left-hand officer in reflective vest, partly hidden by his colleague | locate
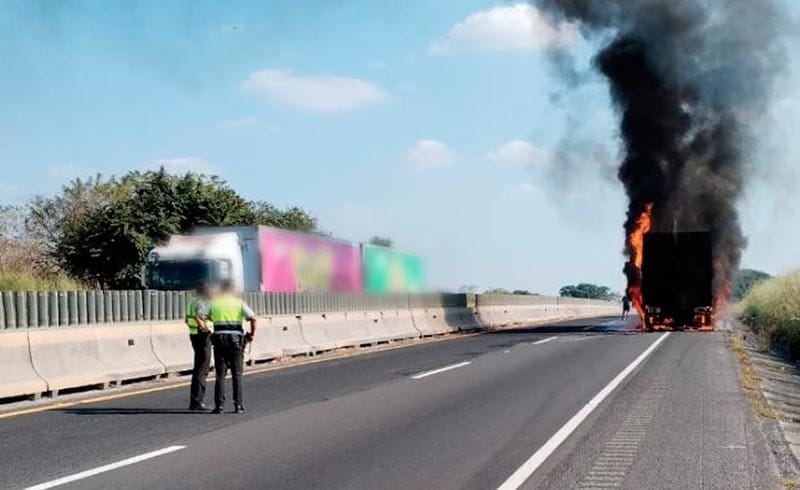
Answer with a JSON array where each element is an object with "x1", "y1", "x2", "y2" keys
[{"x1": 186, "y1": 282, "x2": 214, "y2": 411}]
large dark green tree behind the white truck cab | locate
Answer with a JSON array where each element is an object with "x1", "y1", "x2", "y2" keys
[{"x1": 30, "y1": 169, "x2": 317, "y2": 288}]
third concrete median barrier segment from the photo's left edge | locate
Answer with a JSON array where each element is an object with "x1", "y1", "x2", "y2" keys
[{"x1": 95, "y1": 323, "x2": 165, "y2": 383}]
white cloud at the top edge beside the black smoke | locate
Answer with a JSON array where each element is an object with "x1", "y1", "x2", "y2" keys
[{"x1": 431, "y1": 3, "x2": 580, "y2": 54}]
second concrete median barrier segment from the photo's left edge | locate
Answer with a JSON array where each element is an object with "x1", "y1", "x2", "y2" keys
[{"x1": 28, "y1": 327, "x2": 114, "y2": 395}]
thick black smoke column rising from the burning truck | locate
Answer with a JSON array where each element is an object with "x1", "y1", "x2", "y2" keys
[{"x1": 536, "y1": 0, "x2": 786, "y2": 297}]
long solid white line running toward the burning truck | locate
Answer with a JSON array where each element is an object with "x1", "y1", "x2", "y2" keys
[{"x1": 497, "y1": 332, "x2": 669, "y2": 490}]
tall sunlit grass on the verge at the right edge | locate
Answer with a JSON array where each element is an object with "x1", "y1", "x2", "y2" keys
[{"x1": 739, "y1": 270, "x2": 800, "y2": 359}]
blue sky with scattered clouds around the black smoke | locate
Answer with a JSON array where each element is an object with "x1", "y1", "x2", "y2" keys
[{"x1": 0, "y1": 0, "x2": 800, "y2": 293}]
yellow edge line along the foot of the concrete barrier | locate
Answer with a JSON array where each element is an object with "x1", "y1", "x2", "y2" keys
[{"x1": 0, "y1": 332, "x2": 481, "y2": 420}]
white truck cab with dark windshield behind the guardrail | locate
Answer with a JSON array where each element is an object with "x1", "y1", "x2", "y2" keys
[{"x1": 142, "y1": 232, "x2": 244, "y2": 291}]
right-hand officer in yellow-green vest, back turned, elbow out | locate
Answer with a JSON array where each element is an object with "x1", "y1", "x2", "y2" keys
[{"x1": 211, "y1": 280, "x2": 256, "y2": 413}]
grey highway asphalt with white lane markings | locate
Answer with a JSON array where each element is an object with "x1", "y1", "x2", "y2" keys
[{"x1": 0, "y1": 319, "x2": 780, "y2": 489}]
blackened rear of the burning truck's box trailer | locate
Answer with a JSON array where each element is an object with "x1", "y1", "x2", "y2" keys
[{"x1": 642, "y1": 231, "x2": 714, "y2": 330}]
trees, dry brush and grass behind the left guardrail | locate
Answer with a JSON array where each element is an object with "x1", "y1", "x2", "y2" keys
[{"x1": 0, "y1": 169, "x2": 319, "y2": 290}]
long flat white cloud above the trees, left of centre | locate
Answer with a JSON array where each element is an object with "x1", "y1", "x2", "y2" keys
[{"x1": 243, "y1": 69, "x2": 386, "y2": 113}]
